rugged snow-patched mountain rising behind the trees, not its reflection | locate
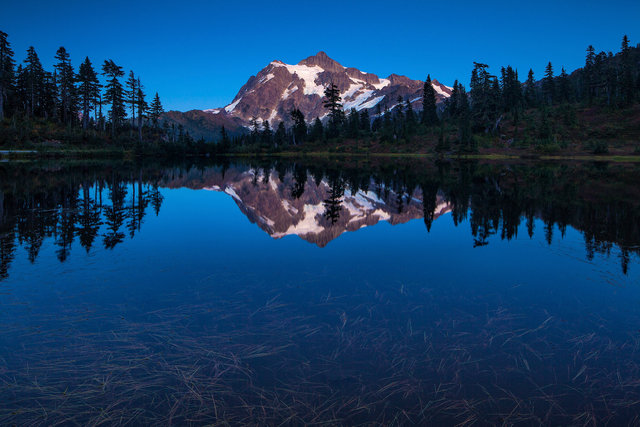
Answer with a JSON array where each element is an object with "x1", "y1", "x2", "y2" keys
[{"x1": 164, "y1": 52, "x2": 451, "y2": 139}]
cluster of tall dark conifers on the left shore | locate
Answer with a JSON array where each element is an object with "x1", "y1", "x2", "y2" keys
[{"x1": 0, "y1": 31, "x2": 171, "y2": 147}]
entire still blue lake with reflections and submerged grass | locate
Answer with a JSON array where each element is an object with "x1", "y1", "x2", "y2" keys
[{"x1": 0, "y1": 160, "x2": 640, "y2": 425}]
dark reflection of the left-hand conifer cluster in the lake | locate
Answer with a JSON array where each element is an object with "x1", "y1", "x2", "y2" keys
[{"x1": 0, "y1": 166, "x2": 163, "y2": 279}]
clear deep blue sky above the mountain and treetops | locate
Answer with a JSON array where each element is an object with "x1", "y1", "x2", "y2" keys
[{"x1": 0, "y1": 0, "x2": 640, "y2": 110}]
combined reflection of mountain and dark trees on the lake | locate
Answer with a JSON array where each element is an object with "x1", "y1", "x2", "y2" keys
[{"x1": 0, "y1": 159, "x2": 640, "y2": 279}]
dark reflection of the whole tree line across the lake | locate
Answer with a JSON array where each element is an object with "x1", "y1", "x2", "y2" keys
[{"x1": 0, "y1": 158, "x2": 640, "y2": 277}]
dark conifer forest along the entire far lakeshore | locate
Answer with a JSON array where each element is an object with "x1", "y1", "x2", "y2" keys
[{"x1": 0, "y1": 31, "x2": 640, "y2": 155}]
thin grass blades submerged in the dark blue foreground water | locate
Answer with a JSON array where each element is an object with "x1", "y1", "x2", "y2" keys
[{"x1": 0, "y1": 275, "x2": 640, "y2": 425}]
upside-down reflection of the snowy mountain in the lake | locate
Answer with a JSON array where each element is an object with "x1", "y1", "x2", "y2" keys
[{"x1": 163, "y1": 168, "x2": 451, "y2": 247}]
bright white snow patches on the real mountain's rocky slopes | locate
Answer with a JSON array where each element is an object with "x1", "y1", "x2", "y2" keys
[{"x1": 203, "y1": 53, "x2": 452, "y2": 121}]
